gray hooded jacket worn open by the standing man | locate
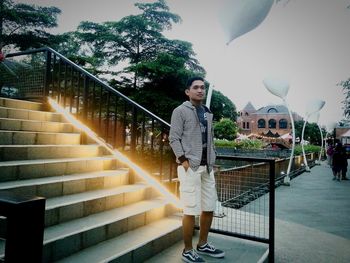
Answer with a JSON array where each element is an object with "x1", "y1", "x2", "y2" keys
[{"x1": 169, "y1": 101, "x2": 216, "y2": 171}]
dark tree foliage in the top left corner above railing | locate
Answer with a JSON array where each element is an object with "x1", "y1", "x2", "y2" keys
[{"x1": 0, "y1": 0, "x2": 61, "y2": 51}]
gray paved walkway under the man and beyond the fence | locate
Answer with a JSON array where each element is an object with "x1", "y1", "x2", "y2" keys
[{"x1": 147, "y1": 163, "x2": 350, "y2": 263}]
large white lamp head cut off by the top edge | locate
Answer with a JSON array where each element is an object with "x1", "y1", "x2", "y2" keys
[{"x1": 219, "y1": 0, "x2": 274, "y2": 44}]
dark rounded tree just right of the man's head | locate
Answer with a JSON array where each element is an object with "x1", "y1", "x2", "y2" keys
[{"x1": 210, "y1": 90, "x2": 237, "y2": 121}]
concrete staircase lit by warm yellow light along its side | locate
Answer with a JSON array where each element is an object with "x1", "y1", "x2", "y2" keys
[{"x1": 0, "y1": 98, "x2": 182, "y2": 263}]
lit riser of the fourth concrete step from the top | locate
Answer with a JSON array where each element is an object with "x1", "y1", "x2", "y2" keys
[{"x1": 0, "y1": 130, "x2": 80, "y2": 145}]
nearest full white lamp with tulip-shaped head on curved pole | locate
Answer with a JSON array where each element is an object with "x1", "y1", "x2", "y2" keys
[{"x1": 263, "y1": 78, "x2": 295, "y2": 185}]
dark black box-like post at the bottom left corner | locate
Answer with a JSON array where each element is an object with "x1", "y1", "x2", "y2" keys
[{"x1": 0, "y1": 191, "x2": 45, "y2": 263}]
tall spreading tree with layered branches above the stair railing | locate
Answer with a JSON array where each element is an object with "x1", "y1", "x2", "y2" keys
[{"x1": 78, "y1": 0, "x2": 181, "y2": 89}]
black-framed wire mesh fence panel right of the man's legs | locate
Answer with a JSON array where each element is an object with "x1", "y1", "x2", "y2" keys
[{"x1": 206, "y1": 157, "x2": 275, "y2": 246}]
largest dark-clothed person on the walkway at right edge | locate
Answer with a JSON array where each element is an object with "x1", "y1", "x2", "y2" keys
[{"x1": 332, "y1": 142, "x2": 348, "y2": 181}]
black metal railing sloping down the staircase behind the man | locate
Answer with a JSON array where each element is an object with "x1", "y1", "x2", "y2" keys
[{"x1": 0, "y1": 48, "x2": 176, "y2": 191}]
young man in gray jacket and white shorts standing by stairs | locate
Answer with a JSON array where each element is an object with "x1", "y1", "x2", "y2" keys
[{"x1": 169, "y1": 77, "x2": 225, "y2": 262}]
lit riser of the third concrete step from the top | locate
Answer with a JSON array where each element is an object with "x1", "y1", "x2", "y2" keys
[{"x1": 0, "y1": 118, "x2": 79, "y2": 132}]
